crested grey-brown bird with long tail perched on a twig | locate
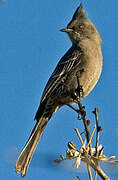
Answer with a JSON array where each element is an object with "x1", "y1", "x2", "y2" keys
[{"x1": 16, "y1": 4, "x2": 102, "y2": 176}]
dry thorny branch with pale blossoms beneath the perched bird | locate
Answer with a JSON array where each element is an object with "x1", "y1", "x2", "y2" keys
[{"x1": 55, "y1": 99, "x2": 118, "y2": 180}]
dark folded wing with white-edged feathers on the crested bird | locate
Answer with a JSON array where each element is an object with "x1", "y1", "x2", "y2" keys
[{"x1": 41, "y1": 45, "x2": 82, "y2": 103}]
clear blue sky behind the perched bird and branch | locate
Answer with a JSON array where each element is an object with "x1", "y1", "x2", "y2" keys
[{"x1": 0, "y1": 0, "x2": 118, "y2": 180}]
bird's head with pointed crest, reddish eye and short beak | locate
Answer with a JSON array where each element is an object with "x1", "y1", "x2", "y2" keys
[{"x1": 61, "y1": 4, "x2": 102, "y2": 44}]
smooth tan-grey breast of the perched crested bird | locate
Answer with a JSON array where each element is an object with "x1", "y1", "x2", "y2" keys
[{"x1": 80, "y1": 41, "x2": 103, "y2": 97}]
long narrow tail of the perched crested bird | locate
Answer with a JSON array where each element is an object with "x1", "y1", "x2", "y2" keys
[{"x1": 15, "y1": 108, "x2": 56, "y2": 177}]
